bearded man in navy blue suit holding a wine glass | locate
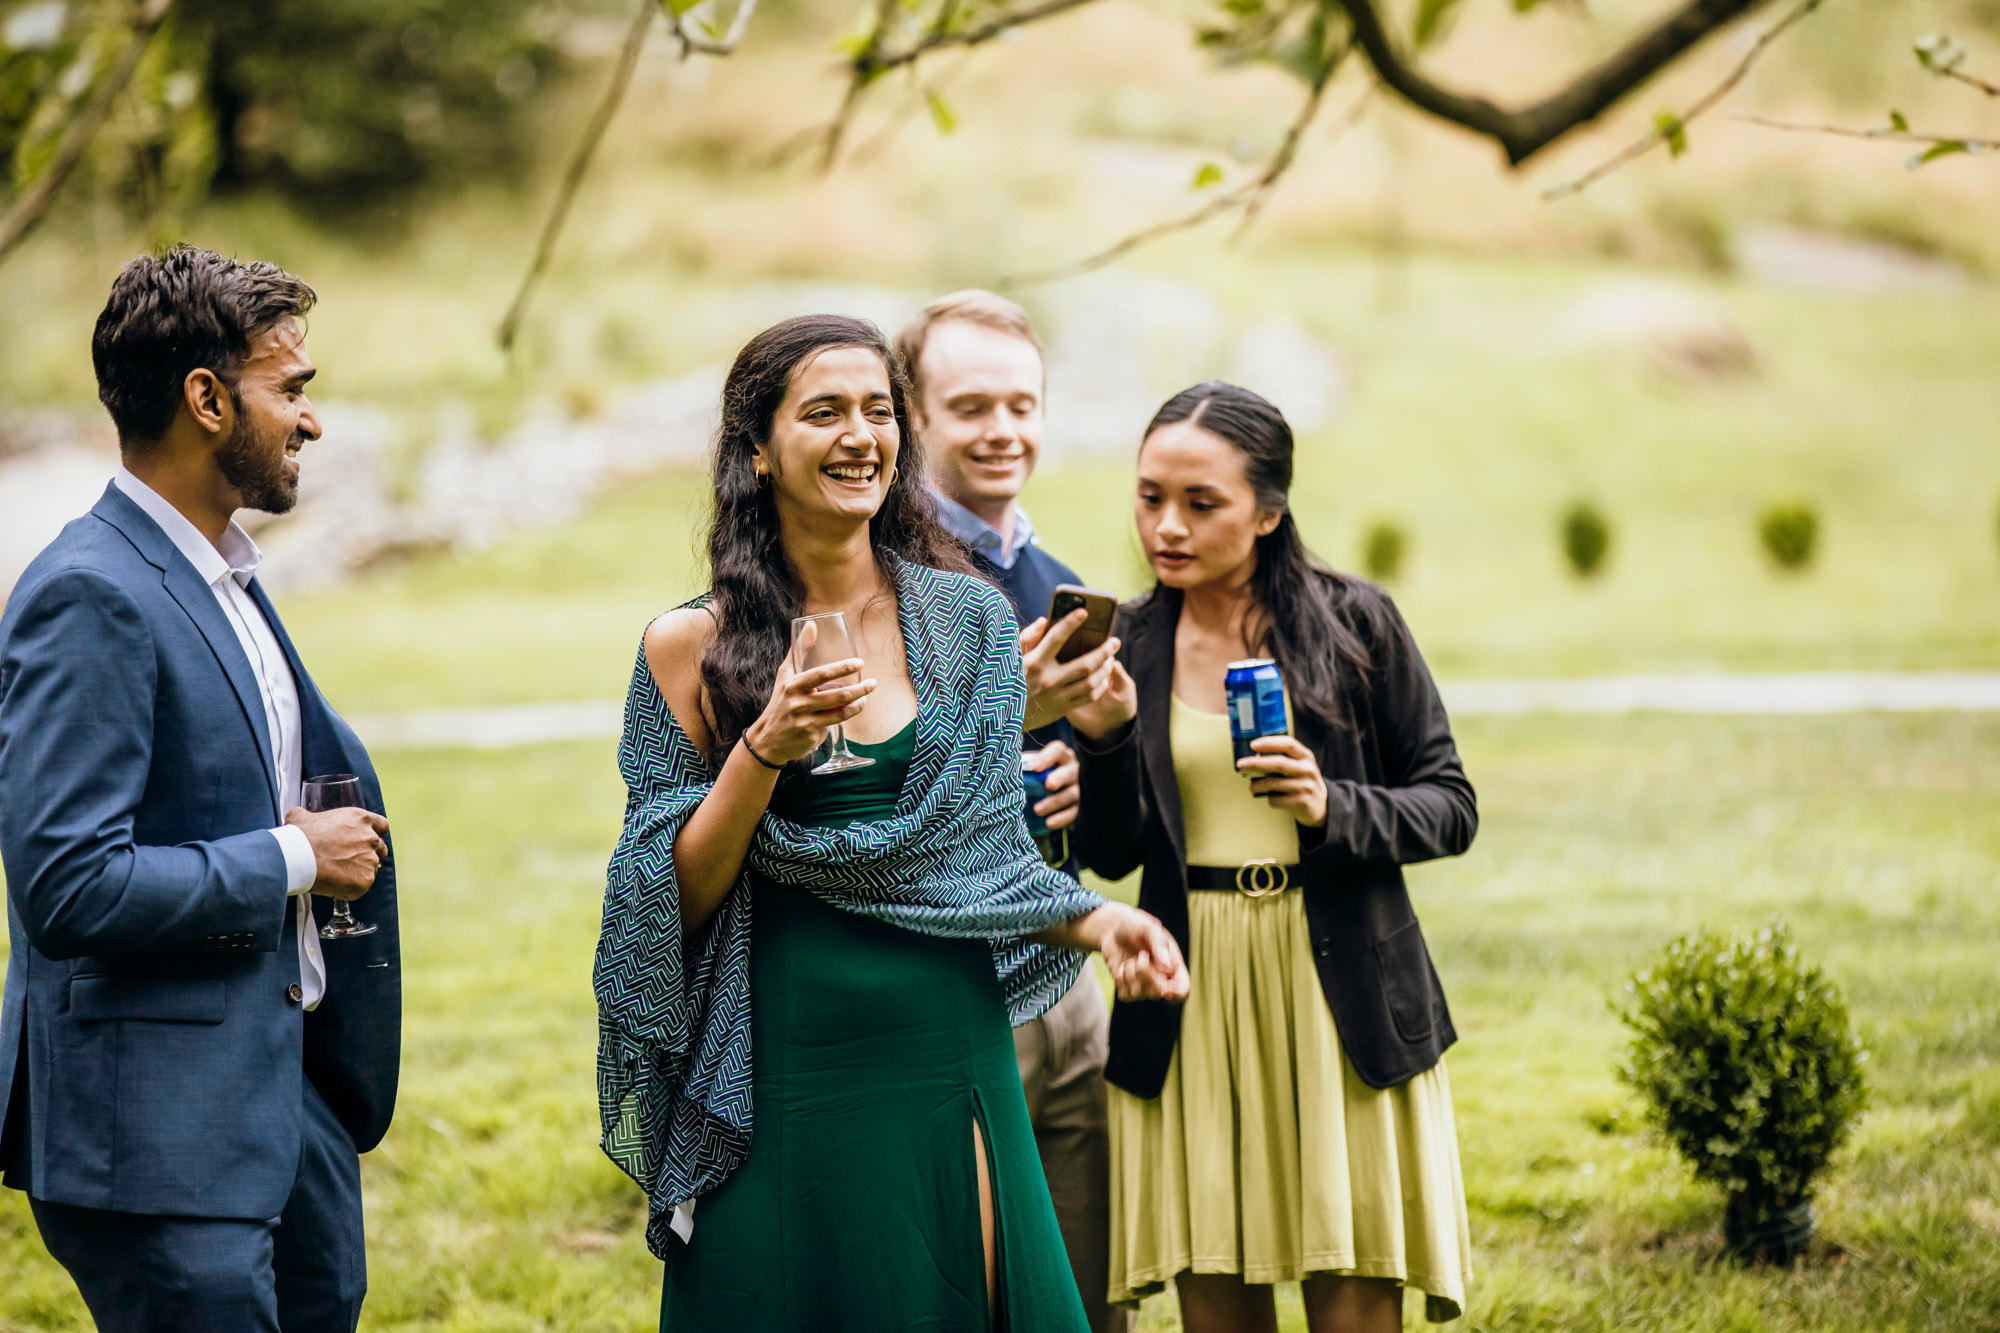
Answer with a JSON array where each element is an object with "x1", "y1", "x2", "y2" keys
[{"x1": 0, "y1": 246, "x2": 402, "y2": 1333}]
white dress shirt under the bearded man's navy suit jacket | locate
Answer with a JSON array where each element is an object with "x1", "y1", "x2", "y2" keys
[{"x1": 116, "y1": 468, "x2": 326, "y2": 1009}]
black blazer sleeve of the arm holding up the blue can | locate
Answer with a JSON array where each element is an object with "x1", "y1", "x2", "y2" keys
[{"x1": 1312, "y1": 594, "x2": 1480, "y2": 865}]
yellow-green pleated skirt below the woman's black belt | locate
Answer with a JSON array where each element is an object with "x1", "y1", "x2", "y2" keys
[{"x1": 1110, "y1": 893, "x2": 1472, "y2": 1321}]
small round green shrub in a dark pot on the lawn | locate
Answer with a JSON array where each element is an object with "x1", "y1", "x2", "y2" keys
[{"x1": 1618, "y1": 923, "x2": 1868, "y2": 1259}]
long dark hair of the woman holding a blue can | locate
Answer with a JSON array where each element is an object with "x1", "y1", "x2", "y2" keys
[{"x1": 1142, "y1": 380, "x2": 1370, "y2": 729}]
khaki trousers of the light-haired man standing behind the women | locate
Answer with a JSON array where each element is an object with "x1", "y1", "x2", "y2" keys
[{"x1": 1014, "y1": 967, "x2": 1132, "y2": 1333}]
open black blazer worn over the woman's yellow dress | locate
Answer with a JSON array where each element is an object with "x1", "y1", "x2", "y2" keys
[{"x1": 1082, "y1": 576, "x2": 1478, "y2": 1097}]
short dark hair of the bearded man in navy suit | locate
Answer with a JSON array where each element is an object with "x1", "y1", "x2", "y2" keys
[{"x1": 90, "y1": 244, "x2": 318, "y2": 452}]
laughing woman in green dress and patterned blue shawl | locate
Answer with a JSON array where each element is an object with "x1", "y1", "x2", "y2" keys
[{"x1": 596, "y1": 316, "x2": 1186, "y2": 1333}]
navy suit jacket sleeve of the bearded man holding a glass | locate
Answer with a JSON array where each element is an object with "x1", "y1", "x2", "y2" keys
[{"x1": 0, "y1": 568, "x2": 286, "y2": 959}]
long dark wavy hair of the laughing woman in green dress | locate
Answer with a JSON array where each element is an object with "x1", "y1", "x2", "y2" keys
[{"x1": 702, "y1": 314, "x2": 970, "y2": 761}]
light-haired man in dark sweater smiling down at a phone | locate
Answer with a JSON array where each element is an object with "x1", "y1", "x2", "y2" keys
[{"x1": 896, "y1": 290, "x2": 1132, "y2": 1333}]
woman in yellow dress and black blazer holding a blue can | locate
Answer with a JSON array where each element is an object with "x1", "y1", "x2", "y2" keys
[{"x1": 1070, "y1": 382, "x2": 1478, "y2": 1333}]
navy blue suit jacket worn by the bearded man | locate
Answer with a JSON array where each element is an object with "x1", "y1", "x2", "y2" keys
[{"x1": 0, "y1": 486, "x2": 402, "y2": 1219}]
